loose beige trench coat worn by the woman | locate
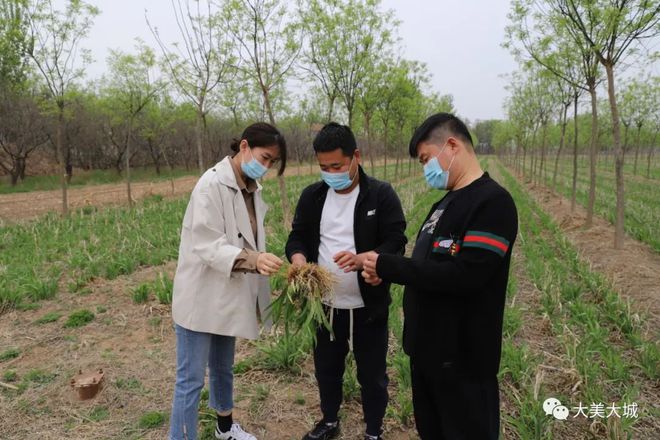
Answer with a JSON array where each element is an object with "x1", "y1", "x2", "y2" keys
[{"x1": 172, "y1": 157, "x2": 270, "y2": 339}]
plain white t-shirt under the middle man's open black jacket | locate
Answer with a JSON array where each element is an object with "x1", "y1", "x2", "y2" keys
[{"x1": 319, "y1": 185, "x2": 364, "y2": 309}]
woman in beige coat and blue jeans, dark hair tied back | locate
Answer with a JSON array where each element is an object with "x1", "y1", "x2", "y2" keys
[{"x1": 169, "y1": 123, "x2": 286, "y2": 440}]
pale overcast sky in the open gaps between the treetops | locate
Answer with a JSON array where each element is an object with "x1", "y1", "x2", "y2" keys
[{"x1": 73, "y1": 0, "x2": 516, "y2": 120}]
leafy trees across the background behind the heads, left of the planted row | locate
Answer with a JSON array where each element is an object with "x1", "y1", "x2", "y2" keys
[{"x1": 0, "y1": 0, "x2": 453, "y2": 217}]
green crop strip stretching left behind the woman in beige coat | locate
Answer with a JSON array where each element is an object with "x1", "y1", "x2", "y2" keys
[{"x1": 0, "y1": 164, "x2": 412, "y2": 314}]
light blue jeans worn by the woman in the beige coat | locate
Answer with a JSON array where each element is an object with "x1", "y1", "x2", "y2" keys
[{"x1": 170, "y1": 325, "x2": 236, "y2": 440}]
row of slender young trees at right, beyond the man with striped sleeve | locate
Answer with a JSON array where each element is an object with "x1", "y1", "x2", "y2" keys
[{"x1": 496, "y1": 0, "x2": 660, "y2": 249}]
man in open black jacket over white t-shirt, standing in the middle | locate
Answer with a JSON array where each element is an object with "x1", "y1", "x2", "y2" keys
[{"x1": 286, "y1": 123, "x2": 406, "y2": 440}]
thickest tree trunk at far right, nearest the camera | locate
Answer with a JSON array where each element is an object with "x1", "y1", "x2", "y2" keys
[{"x1": 605, "y1": 65, "x2": 626, "y2": 249}]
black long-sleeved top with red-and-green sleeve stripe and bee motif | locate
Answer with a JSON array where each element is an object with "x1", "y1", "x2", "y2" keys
[{"x1": 376, "y1": 173, "x2": 518, "y2": 377}]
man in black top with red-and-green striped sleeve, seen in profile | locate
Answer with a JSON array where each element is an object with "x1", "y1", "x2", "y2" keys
[{"x1": 363, "y1": 113, "x2": 518, "y2": 440}]
